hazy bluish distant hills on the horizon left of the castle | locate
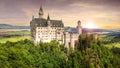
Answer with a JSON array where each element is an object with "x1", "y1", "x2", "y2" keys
[{"x1": 0, "y1": 24, "x2": 30, "y2": 29}]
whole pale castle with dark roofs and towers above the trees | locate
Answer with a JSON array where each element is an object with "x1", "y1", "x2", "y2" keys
[{"x1": 30, "y1": 7, "x2": 82, "y2": 49}]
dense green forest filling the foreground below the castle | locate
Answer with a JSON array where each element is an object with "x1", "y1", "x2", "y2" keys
[{"x1": 0, "y1": 36, "x2": 120, "y2": 68}]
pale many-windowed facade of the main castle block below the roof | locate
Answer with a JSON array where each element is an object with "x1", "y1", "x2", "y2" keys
[{"x1": 36, "y1": 27, "x2": 63, "y2": 43}]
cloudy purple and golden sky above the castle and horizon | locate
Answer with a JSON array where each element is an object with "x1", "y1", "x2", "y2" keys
[{"x1": 0, "y1": 0, "x2": 120, "y2": 29}]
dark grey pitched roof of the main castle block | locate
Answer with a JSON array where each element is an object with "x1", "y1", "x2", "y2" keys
[{"x1": 31, "y1": 18, "x2": 64, "y2": 27}]
